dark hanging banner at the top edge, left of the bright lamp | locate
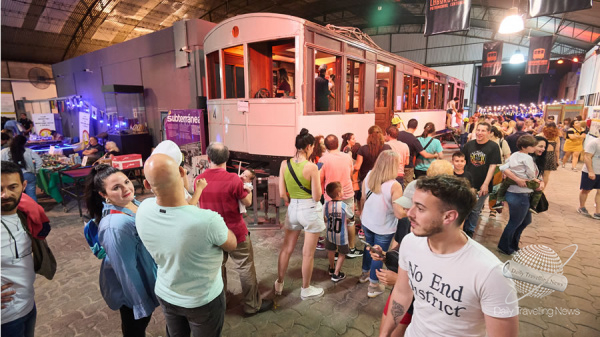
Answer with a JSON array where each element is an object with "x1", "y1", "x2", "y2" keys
[{"x1": 425, "y1": 0, "x2": 471, "y2": 36}]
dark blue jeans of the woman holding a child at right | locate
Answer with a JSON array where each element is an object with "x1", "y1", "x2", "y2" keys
[{"x1": 498, "y1": 192, "x2": 531, "y2": 254}]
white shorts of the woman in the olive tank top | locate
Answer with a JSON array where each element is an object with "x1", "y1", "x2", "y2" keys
[{"x1": 285, "y1": 199, "x2": 325, "y2": 233}]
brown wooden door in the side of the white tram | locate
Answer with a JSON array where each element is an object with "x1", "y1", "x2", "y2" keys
[{"x1": 375, "y1": 63, "x2": 395, "y2": 130}]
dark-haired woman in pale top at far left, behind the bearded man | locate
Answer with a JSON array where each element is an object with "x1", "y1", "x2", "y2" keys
[{"x1": 0, "y1": 135, "x2": 42, "y2": 202}]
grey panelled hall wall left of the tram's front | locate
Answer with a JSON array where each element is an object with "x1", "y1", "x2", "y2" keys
[{"x1": 53, "y1": 20, "x2": 216, "y2": 144}]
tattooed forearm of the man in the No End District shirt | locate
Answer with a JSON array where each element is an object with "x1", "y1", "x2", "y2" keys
[{"x1": 379, "y1": 268, "x2": 413, "y2": 337}]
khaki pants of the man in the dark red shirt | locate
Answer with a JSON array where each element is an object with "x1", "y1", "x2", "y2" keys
[{"x1": 221, "y1": 235, "x2": 262, "y2": 313}]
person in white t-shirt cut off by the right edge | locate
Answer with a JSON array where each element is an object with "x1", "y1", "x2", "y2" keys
[{"x1": 577, "y1": 137, "x2": 600, "y2": 220}]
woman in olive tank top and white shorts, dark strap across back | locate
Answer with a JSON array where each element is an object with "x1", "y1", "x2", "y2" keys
[{"x1": 275, "y1": 129, "x2": 325, "y2": 300}]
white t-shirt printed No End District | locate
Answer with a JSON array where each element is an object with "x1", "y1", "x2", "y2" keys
[{"x1": 398, "y1": 233, "x2": 519, "y2": 337}]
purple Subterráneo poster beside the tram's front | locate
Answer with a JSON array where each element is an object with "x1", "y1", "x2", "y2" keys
[{"x1": 165, "y1": 109, "x2": 208, "y2": 186}]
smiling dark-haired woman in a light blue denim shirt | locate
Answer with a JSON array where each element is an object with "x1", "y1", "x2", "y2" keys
[{"x1": 85, "y1": 164, "x2": 159, "y2": 337}]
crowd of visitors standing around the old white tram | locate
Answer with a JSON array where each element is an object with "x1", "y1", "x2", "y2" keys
[{"x1": 2, "y1": 107, "x2": 600, "y2": 336}]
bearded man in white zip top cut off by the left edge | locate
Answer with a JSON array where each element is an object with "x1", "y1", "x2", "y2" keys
[{"x1": 1, "y1": 161, "x2": 37, "y2": 337}]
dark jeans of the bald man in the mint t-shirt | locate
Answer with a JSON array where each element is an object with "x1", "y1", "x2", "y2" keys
[{"x1": 157, "y1": 291, "x2": 225, "y2": 337}]
